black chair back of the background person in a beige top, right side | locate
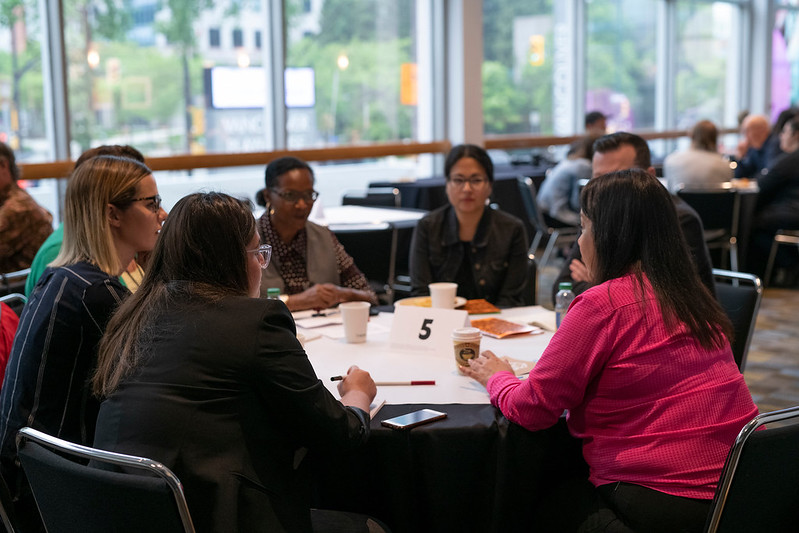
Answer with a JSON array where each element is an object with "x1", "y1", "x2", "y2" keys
[{"x1": 677, "y1": 183, "x2": 741, "y2": 272}]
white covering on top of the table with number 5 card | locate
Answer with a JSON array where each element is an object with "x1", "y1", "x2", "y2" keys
[{"x1": 295, "y1": 306, "x2": 555, "y2": 404}]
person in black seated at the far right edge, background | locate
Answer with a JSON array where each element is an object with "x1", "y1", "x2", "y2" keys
[{"x1": 746, "y1": 117, "x2": 799, "y2": 276}]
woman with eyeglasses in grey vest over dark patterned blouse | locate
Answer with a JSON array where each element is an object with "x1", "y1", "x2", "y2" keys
[{"x1": 258, "y1": 157, "x2": 377, "y2": 311}]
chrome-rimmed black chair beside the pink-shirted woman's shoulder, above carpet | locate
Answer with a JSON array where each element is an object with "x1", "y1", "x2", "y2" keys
[{"x1": 713, "y1": 268, "x2": 763, "y2": 372}]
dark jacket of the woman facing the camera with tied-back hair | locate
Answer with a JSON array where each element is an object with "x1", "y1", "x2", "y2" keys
[{"x1": 410, "y1": 204, "x2": 530, "y2": 307}]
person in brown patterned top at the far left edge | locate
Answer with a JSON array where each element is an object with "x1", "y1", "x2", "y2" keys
[{"x1": 0, "y1": 142, "x2": 53, "y2": 273}]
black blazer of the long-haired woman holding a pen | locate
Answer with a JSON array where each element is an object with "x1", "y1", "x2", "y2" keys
[{"x1": 94, "y1": 296, "x2": 369, "y2": 532}]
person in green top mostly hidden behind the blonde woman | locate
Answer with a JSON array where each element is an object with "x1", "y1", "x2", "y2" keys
[{"x1": 25, "y1": 144, "x2": 144, "y2": 296}]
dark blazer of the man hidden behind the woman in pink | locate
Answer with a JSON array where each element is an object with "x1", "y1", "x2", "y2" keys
[{"x1": 552, "y1": 196, "x2": 716, "y2": 304}]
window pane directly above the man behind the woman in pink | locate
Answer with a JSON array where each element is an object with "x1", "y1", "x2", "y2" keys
[{"x1": 585, "y1": 0, "x2": 658, "y2": 131}]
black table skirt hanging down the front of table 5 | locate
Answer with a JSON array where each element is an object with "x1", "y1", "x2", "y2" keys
[{"x1": 314, "y1": 404, "x2": 588, "y2": 533}]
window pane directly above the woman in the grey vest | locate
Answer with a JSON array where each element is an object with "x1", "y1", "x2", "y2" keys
[{"x1": 286, "y1": 0, "x2": 418, "y2": 148}]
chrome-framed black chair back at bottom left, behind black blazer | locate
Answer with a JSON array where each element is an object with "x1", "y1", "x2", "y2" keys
[{"x1": 17, "y1": 427, "x2": 194, "y2": 533}]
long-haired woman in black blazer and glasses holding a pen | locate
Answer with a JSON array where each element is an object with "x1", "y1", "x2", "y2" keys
[{"x1": 93, "y1": 193, "x2": 376, "y2": 531}]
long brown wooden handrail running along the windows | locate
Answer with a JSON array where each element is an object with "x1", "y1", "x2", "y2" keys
[{"x1": 19, "y1": 128, "x2": 738, "y2": 180}]
